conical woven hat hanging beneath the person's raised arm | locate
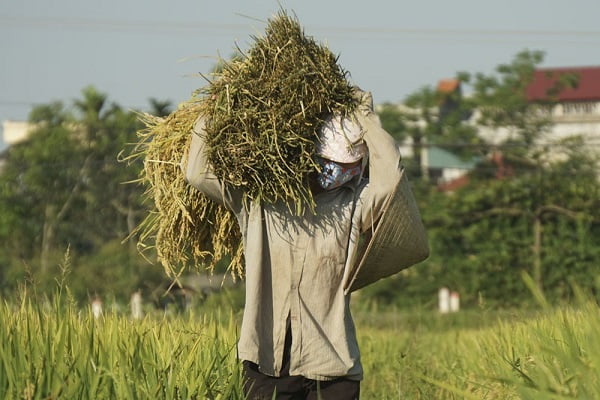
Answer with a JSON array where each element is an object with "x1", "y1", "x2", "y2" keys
[{"x1": 346, "y1": 170, "x2": 429, "y2": 292}]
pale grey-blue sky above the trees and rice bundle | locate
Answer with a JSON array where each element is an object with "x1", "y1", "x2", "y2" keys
[{"x1": 0, "y1": 0, "x2": 600, "y2": 147}]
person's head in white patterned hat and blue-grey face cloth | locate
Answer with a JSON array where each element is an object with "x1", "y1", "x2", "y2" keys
[{"x1": 317, "y1": 116, "x2": 368, "y2": 189}]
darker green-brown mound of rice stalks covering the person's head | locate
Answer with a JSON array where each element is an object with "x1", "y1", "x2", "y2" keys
[{"x1": 200, "y1": 11, "x2": 356, "y2": 214}]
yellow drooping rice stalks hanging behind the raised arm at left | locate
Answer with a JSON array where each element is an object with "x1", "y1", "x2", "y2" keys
[{"x1": 132, "y1": 100, "x2": 242, "y2": 276}]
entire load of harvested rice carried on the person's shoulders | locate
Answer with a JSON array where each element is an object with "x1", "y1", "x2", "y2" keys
[{"x1": 133, "y1": 10, "x2": 357, "y2": 274}]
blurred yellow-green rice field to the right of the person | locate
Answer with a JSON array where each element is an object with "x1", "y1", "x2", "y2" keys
[{"x1": 358, "y1": 301, "x2": 600, "y2": 400}]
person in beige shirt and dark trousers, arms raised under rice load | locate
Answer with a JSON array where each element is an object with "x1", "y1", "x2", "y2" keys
[{"x1": 186, "y1": 90, "x2": 401, "y2": 400}]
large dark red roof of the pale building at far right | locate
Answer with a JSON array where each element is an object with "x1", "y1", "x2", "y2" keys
[{"x1": 526, "y1": 67, "x2": 600, "y2": 102}]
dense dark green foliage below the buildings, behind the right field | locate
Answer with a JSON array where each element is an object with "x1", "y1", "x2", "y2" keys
[{"x1": 396, "y1": 162, "x2": 600, "y2": 305}]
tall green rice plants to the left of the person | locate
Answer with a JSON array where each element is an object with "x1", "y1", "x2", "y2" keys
[{"x1": 0, "y1": 290, "x2": 243, "y2": 399}]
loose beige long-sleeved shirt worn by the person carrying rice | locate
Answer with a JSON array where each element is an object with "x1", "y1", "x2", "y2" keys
[{"x1": 186, "y1": 97, "x2": 400, "y2": 380}]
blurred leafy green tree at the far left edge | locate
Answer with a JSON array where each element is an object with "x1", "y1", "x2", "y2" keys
[{"x1": 3, "y1": 103, "x2": 85, "y2": 271}]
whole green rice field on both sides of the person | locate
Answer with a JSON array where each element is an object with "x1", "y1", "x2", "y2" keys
[{"x1": 0, "y1": 284, "x2": 600, "y2": 400}]
